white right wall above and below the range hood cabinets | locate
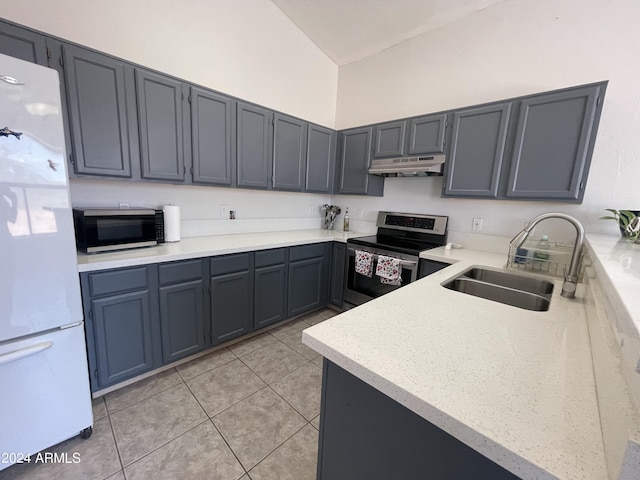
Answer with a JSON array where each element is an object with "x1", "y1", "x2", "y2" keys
[{"x1": 333, "y1": 0, "x2": 640, "y2": 246}]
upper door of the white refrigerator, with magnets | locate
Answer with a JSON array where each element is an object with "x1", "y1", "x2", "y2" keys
[{"x1": 0, "y1": 55, "x2": 83, "y2": 343}]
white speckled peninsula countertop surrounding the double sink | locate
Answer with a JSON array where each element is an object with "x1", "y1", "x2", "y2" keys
[{"x1": 303, "y1": 244, "x2": 607, "y2": 480}]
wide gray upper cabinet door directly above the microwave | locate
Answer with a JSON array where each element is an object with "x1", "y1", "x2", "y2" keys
[{"x1": 62, "y1": 45, "x2": 135, "y2": 178}]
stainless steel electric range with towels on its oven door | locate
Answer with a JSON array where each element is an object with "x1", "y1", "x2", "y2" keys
[{"x1": 343, "y1": 212, "x2": 449, "y2": 305}]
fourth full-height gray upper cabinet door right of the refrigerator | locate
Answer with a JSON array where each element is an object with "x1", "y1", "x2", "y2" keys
[{"x1": 236, "y1": 102, "x2": 272, "y2": 188}]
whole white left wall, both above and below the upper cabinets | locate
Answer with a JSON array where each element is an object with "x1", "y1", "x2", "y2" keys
[{"x1": 0, "y1": 0, "x2": 338, "y2": 232}]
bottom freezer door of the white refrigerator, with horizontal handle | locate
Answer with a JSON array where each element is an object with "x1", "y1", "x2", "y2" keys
[{"x1": 0, "y1": 323, "x2": 93, "y2": 470}]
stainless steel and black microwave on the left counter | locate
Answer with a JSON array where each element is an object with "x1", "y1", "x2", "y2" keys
[{"x1": 73, "y1": 208, "x2": 164, "y2": 253}]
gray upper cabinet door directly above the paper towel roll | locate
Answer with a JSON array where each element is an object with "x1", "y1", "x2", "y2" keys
[{"x1": 136, "y1": 69, "x2": 185, "y2": 182}]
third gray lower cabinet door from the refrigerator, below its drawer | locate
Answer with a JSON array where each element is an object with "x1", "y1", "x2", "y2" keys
[{"x1": 211, "y1": 271, "x2": 253, "y2": 345}]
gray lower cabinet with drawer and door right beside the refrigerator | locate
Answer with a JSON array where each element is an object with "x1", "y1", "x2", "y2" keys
[{"x1": 80, "y1": 266, "x2": 162, "y2": 391}]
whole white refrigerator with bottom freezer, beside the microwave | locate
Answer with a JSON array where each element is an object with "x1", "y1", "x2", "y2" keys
[{"x1": 0, "y1": 54, "x2": 93, "y2": 470}]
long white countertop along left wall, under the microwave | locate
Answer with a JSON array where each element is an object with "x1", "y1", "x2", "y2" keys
[{"x1": 78, "y1": 229, "x2": 365, "y2": 272}]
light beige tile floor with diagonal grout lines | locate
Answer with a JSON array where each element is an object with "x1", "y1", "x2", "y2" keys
[{"x1": 0, "y1": 309, "x2": 335, "y2": 480}]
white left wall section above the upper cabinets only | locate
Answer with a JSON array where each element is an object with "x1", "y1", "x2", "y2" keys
[{"x1": 0, "y1": 0, "x2": 338, "y2": 127}]
